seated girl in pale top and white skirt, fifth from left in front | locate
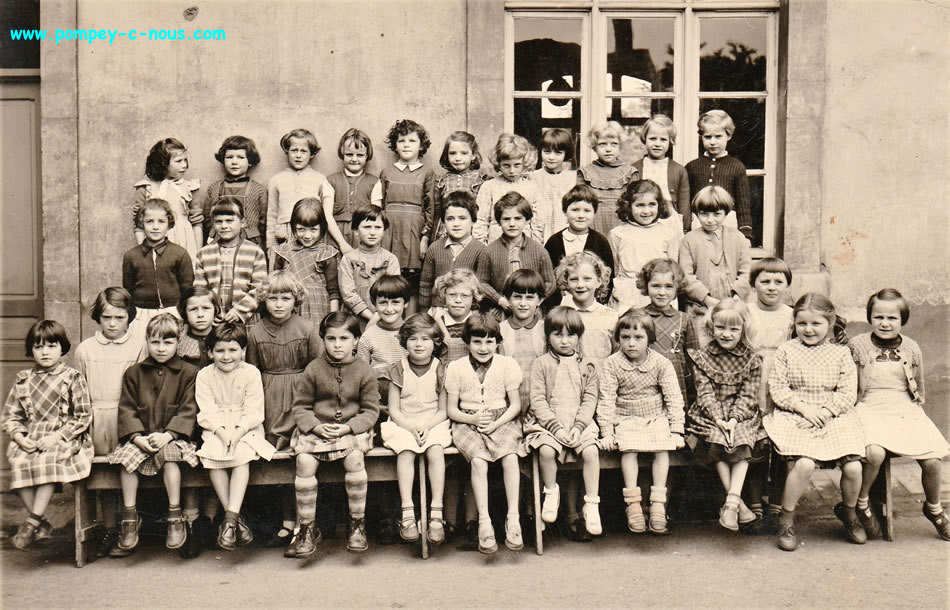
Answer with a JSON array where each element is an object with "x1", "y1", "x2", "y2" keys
[{"x1": 381, "y1": 313, "x2": 452, "y2": 544}]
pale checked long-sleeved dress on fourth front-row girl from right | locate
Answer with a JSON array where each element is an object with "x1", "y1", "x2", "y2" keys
[{"x1": 597, "y1": 349, "x2": 686, "y2": 452}]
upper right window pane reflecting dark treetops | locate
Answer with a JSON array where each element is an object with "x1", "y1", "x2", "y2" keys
[{"x1": 699, "y1": 17, "x2": 768, "y2": 91}]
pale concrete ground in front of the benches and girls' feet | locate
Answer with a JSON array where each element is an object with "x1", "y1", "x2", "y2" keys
[{"x1": 0, "y1": 462, "x2": 950, "y2": 608}]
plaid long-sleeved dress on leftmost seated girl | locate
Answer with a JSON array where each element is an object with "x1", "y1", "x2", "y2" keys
[{"x1": 3, "y1": 363, "x2": 93, "y2": 489}]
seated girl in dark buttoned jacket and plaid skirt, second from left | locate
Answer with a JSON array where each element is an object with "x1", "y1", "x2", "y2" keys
[{"x1": 109, "y1": 313, "x2": 198, "y2": 551}]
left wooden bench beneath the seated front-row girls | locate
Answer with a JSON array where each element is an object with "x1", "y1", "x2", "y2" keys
[{"x1": 73, "y1": 447, "x2": 458, "y2": 568}]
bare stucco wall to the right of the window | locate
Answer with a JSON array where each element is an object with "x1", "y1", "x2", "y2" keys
[{"x1": 820, "y1": 0, "x2": 950, "y2": 304}]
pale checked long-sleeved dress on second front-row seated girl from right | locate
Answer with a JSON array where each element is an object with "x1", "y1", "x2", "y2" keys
[{"x1": 762, "y1": 339, "x2": 865, "y2": 461}]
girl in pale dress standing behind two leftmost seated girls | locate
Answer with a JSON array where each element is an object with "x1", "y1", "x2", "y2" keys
[{"x1": 76, "y1": 286, "x2": 146, "y2": 557}]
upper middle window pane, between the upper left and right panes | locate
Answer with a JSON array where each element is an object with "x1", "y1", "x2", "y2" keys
[{"x1": 607, "y1": 17, "x2": 674, "y2": 93}]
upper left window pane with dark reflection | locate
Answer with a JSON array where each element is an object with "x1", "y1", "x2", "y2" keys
[{"x1": 515, "y1": 17, "x2": 582, "y2": 91}]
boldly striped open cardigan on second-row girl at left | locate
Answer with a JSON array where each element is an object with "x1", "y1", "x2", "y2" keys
[{"x1": 194, "y1": 239, "x2": 267, "y2": 322}]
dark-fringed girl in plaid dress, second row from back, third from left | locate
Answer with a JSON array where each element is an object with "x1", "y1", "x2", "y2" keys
[{"x1": 273, "y1": 197, "x2": 340, "y2": 324}]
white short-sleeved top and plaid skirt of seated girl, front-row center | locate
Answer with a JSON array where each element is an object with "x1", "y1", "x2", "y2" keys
[{"x1": 445, "y1": 354, "x2": 527, "y2": 462}]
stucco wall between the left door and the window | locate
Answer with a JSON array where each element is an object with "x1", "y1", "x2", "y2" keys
[{"x1": 69, "y1": 0, "x2": 468, "y2": 335}]
